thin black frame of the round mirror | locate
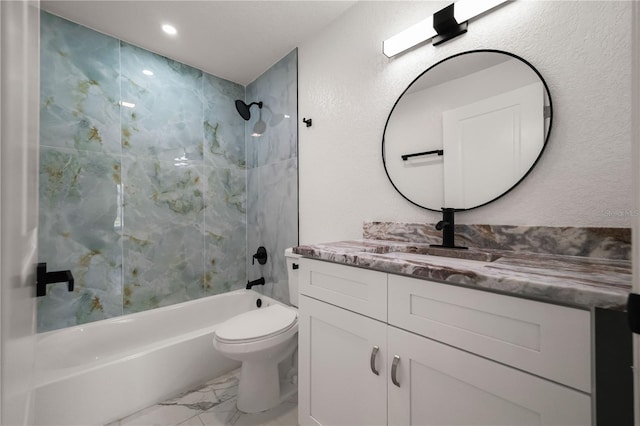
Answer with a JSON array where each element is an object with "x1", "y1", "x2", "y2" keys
[{"x1": 382, "y1": 49, "x2": 553, "y2": 212}]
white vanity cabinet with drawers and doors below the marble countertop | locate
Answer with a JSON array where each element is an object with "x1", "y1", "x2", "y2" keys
[{"x1": 298, "y1": 259, "x2": 592, "y2": 426}]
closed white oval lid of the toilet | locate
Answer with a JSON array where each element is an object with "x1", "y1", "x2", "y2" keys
[{"x1": 215, "y1": 304, "x2": 298, "y2": 343}]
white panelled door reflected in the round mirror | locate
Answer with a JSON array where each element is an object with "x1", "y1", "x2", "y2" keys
[{"x1": 442, "y1": 83, "x2": 544, "y2": 209}]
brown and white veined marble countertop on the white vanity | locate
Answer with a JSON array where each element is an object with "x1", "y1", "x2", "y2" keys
[{"x1": 293, "y1": 239, "x2": 631, "y2": 310}]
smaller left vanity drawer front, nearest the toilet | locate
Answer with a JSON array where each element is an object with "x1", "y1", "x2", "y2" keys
[{"x1": 298, "y1": 258, "x2": 387, "y2": 322}]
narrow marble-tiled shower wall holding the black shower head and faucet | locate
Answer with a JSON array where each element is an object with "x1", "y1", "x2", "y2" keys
[{"x1": 246, "y1": 50, "x2": 298, "y2": 302}]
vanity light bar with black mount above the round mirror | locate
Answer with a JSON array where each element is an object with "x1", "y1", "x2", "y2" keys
[{"x1": 382, "y1": 0, "x2": 513, "y2": 58}]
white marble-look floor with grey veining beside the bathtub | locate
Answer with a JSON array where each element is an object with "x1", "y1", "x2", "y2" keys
[{"x1": 107, "y1": 369, "x2": 298, "y2": 426}]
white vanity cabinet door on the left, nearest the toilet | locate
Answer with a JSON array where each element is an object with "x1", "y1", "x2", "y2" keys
[{"x1": 298, "y1": 295, "x2": 387, "y2": 426}]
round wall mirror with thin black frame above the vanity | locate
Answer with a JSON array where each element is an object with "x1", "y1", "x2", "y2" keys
[{"x1": 382, "y1": 50, "x2": 553, "y2": 211}]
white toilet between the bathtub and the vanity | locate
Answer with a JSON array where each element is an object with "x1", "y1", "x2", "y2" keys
[{"x1": 213, "y1": 248, "x2": 301, "y2": 413}]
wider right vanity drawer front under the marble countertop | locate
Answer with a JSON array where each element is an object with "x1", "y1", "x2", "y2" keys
[{"x1": 388, "y1": 275, "x2": 591, "y2": 393}]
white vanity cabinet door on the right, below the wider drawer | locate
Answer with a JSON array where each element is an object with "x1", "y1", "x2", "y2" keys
[{"x1": 388, "y1": 327, "x2": 591, "y2": 426}]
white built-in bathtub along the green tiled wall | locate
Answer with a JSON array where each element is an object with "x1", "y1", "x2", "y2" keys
[{"x1": 35, "y1": 290, "x2": 279, "y2": 425}]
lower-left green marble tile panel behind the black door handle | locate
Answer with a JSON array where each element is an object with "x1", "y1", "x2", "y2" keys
[{"x1": 38, "y1": 147, "x2": 122, "y2": 331}]
